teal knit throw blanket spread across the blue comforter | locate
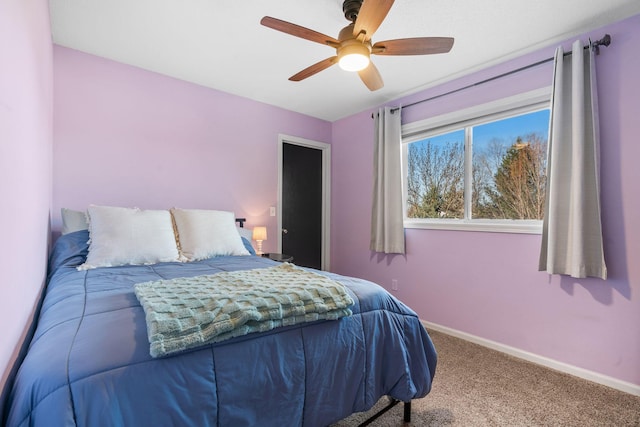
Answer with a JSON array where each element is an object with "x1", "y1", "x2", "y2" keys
[{"x1": 135, "y1": 263, "x2": 353, "y2": 357}]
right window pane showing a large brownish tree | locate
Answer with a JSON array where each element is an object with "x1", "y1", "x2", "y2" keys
[{"x1": 471, "y1": 110, "x2": 549, "y2": 220}]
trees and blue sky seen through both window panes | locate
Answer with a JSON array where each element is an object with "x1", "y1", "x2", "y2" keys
[{"x1": 406, "y1": 109, "x2": 549, "y2": 220}]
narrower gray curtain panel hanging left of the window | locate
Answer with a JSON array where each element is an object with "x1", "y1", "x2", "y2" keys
[{"x1": 369, "y1": 107, "x2": 405, "y2": 254}]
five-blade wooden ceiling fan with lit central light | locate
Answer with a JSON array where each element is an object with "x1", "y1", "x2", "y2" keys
[{"x1": 260, "y1": 0, "x2": 453, "y2": 91}]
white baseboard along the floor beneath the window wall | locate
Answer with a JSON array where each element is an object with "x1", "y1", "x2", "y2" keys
[{"x1": 421, "y1": 320, "x2": 640, "y2": 396}]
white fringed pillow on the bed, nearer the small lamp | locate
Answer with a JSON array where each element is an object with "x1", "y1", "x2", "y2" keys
[{"x1": 171, "y1": 208, "x2": 250, "y2": 261}]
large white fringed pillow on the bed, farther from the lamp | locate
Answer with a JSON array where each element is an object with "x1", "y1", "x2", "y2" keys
[{"x1": 78, "y1": 205, "x2": 179, "y2": 270}]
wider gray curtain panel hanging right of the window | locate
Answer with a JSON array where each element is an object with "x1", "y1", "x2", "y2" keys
[{"x1": 539, "y1": 40, "x2": 607, "y2": 279}]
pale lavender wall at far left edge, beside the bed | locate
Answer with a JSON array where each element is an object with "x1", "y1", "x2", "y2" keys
[{"x1": 0, "y1": 0, "x2": 53, "y2": 394}]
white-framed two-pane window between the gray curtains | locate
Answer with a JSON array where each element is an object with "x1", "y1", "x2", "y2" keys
[{"x1": 403, "y1": 89, "x2": 550, "y2": 233}]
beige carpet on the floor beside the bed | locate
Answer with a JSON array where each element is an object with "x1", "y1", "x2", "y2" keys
[{"x1": 334, "y1": 331, "x2": 640, "y2": 427}]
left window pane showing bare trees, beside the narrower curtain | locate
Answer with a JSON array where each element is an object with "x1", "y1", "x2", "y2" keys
[{"x1": 407, "y1": 130, "x2": 464, "y2": 218}]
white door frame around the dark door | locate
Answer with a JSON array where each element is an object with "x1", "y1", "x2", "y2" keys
[{"x1": 278, "y1": 134, "x2": 331, "y2": 270}]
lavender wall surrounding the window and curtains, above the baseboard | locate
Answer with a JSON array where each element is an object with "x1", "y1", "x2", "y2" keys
[{"x1": 332, "y1": 16, "x2": 640, "y2": 385}]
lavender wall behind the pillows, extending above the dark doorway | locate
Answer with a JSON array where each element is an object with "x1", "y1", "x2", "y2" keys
[{"x1": 53, "y1": 46, "x2": 331, "y2": 251}]
